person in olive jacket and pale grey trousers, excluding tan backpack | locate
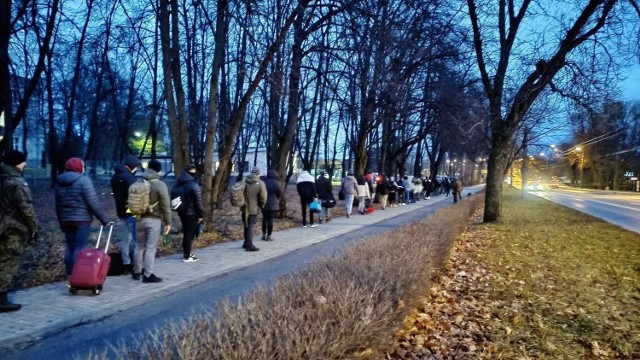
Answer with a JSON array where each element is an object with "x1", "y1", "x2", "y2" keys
[{"x1": 132, "y1": 159, "x2": 171, "y2": 283}]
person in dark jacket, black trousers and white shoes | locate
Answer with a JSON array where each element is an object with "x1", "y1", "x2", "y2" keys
[{"x1": 171, "y1": 164, "x2": 204, "y2": 263}]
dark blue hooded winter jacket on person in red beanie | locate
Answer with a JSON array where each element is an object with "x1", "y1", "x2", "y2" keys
[{"x1": 55, "y1": 171, "x2": 109, "y2": 225}]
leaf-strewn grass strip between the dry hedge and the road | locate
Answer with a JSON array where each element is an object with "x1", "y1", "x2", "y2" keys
[{"x1": 389, "y1": 190, "x2": 640, "y2": 359}]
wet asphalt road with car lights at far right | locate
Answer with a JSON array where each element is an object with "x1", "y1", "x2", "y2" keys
[{"x1": 530, "y1": 187, "x2": 640, "y2": 233}]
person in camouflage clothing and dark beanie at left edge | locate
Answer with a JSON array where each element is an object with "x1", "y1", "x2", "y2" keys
[{"x1": 0, "y1": 150, "x2": 38, "y2": 312}]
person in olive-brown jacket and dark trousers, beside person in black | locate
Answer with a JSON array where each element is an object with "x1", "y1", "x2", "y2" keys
[{"x1": 240, "y1": 167, "x2": 268, "y2": 251}]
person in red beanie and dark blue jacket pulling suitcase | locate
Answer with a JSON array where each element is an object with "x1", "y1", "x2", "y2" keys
[{"x1": 55, "y1": 157, "x2": 111, "y2": 276}]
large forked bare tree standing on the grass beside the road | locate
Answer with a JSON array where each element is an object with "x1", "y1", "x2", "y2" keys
[{"x1": 467, "y1": 0, "x2": 638, "y2": 222}]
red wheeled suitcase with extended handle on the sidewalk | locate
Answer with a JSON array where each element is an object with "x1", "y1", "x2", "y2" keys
[{"x1": 69, "y1": 224, "x2": 113, "y2": 295}]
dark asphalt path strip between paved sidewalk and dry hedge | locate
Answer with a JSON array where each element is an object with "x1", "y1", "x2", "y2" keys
[{"x1": 6, "y1": 200, "x2": 452, "y2": 360}]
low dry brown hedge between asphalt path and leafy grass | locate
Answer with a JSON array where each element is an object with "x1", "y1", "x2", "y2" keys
[{"x1": 87, "y1": 197, "x2": 482, "y2": 360}]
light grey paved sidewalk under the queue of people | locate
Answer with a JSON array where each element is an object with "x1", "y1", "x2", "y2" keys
[{"x1": 0, "y1": 193, "x2": 475, "y2": 349}]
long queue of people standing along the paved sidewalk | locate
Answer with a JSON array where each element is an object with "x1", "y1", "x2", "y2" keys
[{"x1": 0, "y1": 150, "x2": 462, "y2": 312}]
